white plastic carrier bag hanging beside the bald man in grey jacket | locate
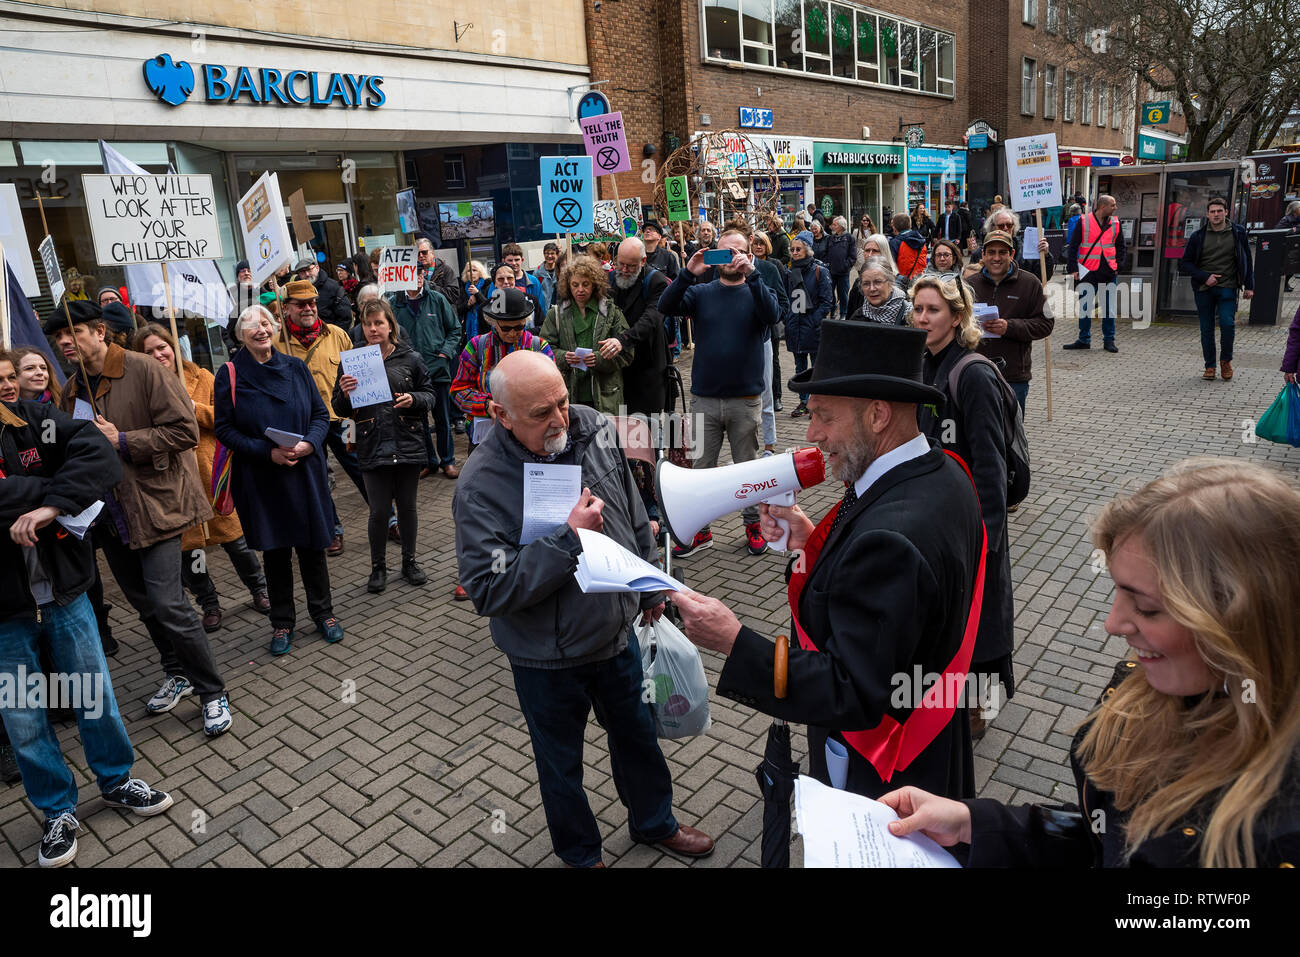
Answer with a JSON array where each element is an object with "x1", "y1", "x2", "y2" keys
[{"x1": 636, "y1": 615, "x2": 712, "y2": 737}]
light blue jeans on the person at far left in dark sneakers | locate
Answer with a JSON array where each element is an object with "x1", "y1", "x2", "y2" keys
[{"x1": 0, "y1": 594, "x2": 135, "y2": 820}]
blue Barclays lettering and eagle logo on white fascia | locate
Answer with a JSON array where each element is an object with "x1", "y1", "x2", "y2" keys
[{"x1": 144, "y1": 53, "x2": 387, "y2": 109}]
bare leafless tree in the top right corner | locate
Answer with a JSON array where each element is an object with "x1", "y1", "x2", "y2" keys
[{"x1": 1067, "y1": 0, "x2": 1300, "y2": 160}]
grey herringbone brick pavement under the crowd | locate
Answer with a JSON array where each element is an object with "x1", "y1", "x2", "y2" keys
[{"x1": 0, "y1": 300, "x2": 1300, "y2": 867}]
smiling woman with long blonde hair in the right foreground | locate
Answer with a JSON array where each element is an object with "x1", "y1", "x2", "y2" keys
[{"x1": 880, "y1": 459, "x2": 1300, "y2": 867}]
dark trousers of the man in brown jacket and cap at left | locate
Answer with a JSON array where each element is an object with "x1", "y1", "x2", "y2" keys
[{"x1": 101, "y1": 534, "x2": 225, "y2": 705}]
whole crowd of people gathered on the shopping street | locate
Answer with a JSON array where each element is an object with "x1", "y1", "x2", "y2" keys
[{"x1": 0, "y1": 196, "x2": 1300, "y2": 867}]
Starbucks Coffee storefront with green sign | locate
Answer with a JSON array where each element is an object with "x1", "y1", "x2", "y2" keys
[{"x1": 813, "y1": 140, "x2": 907, "y2": 230}]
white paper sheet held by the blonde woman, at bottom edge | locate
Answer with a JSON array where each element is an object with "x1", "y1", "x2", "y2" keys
[{"x1": 794, "y1": 775, "x2": 961, "y2": 867}]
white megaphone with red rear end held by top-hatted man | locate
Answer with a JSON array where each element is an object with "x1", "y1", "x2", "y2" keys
[{"x1": 654, "y1": 449, "x2": 826, "y2": 551}]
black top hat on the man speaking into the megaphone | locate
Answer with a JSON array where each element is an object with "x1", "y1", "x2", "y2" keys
[{"x1": 789, "y1": 319, "x2": 944, "y2": 406}]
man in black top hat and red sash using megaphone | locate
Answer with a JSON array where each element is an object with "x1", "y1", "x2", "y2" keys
[{"x1": 673, "y1": 320, "x2": 983, "y2": 798}]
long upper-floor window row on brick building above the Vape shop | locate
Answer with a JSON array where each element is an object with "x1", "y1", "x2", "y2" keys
[{"x1": 701, "y1": 0, "x2": 956, "y2": 96}]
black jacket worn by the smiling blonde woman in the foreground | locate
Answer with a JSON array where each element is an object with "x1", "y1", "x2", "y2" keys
[{"x1": 965, "y1": 662, "x2": 1300, "y2": 867}]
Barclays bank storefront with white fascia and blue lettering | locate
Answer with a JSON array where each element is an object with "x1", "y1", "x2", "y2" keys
[{"x1": 0, "y1": 10, "x2": 586, "y2": 366}]
